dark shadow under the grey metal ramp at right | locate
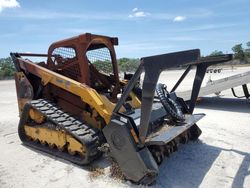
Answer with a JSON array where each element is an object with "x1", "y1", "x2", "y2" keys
[{"x1": 196, "y1": 97, "x2": 250, "y2": 113}]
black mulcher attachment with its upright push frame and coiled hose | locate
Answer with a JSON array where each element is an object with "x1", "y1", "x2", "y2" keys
[{"x1": 103, "y1": 50, "x2": 207, "y2": 184}]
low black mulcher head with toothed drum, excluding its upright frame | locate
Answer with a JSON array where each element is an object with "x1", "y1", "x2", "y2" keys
[{"x1": 103, "y1": 114, "x2": 204, "y2": 185}]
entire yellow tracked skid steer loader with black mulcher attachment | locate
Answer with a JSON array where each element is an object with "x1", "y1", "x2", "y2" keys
[{"x1": 11, "y1": 33, "x2": 231, "y2": 184}]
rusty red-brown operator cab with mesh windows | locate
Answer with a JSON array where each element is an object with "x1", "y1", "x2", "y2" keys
[{"x1": 47, "y1": 33, "x2": 120, "y2": 102}]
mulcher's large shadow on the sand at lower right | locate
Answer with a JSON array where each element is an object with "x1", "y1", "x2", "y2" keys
[{"x1": 153, "y1": 141, "x2": 250, "y2": 188}]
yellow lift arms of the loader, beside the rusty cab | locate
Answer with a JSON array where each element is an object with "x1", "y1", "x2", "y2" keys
[{"x1": 20, "y1": 59, "x2": 141, "y2": 124}]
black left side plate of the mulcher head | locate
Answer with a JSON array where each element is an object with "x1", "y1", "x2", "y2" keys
[{"x1": 103, "y1": 118, "x2": 158, "y2": 184}]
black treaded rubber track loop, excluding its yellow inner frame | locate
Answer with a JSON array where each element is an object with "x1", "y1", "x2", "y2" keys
[{"x1": 18, "y1": 99, "x2": 102, "y2": 165}]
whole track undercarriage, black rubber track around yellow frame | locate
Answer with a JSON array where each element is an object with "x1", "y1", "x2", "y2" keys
[{"x1": 18, "y1": 99, "x2": 102, "y2": 165}]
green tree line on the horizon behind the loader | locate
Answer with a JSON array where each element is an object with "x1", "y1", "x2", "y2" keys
[{"x1": 0, "y1": 42, "x2": 250, "y2": 79}]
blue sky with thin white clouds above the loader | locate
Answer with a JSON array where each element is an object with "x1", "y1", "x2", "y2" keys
[{"x1": 0, "y1": 0, "x2": 250, "y2": 58}]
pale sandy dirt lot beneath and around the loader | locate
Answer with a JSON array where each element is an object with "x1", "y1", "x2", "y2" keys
[{"x1": 0, "y1": 68, "x2": 250, "y2": 188}]
